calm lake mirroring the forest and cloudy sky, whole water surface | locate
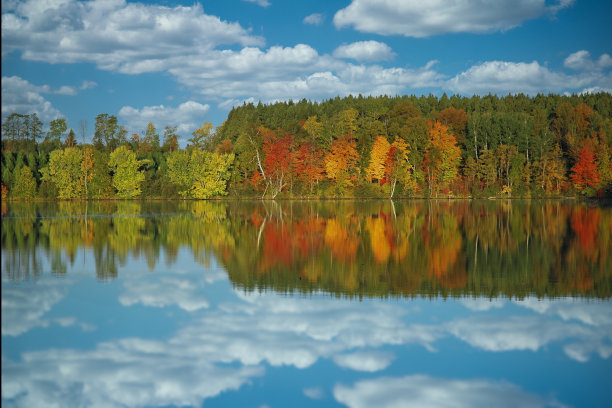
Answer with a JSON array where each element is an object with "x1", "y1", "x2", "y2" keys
[{"x1": 2, "y1": 200, "x2": 612, "y2": 407}]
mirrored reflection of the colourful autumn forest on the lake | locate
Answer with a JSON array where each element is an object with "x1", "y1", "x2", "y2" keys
[{"x1": 2, "y1": 201, "x2": 612, "y2": 298}]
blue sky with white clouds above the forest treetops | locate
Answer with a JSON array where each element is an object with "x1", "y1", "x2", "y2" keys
[{"x1": 2, "y1": 0, "x2": 612, "y2": 145}]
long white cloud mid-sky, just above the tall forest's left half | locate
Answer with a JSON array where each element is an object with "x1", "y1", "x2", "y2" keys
[{"x1": 170, "y1": 44, "x2": 442, "y2": 102}]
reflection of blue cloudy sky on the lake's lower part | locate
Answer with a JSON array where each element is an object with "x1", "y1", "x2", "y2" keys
[{"x1": 2, "y1": 247, "x2": 612, "y2": 407}]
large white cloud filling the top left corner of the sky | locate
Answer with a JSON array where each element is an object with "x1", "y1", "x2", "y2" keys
[{"x1": 2, "y1": 0, "x2": 263, "y2": 73}]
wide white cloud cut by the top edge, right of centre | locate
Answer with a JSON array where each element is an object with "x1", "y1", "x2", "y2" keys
[{"x1": 334, "y1": 0, "x2": 573, "y2": 37}]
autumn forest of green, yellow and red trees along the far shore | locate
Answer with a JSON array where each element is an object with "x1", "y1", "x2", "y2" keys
[{"x1": 1, "y1": 92, "x2": 612, "y2": 200}]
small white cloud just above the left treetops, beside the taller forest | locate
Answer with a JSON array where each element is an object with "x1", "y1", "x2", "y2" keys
[{"x1": 119, "y1": 101, "x2": 210, "y2": 136}]
